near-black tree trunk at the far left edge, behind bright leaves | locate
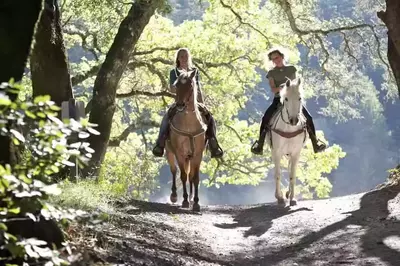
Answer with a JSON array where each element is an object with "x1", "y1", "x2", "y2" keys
[{"x1": 0, "y1": 0, "x2": 42, "y2": 165}]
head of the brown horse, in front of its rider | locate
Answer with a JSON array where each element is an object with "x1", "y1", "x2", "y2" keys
[{"x1": 174, "y1": 70, "x2": 197, "y2": 104}]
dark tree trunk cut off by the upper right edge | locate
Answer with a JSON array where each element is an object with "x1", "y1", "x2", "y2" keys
[{"x1": 378, "y1": 0, "x2": 400, "y2": 96}]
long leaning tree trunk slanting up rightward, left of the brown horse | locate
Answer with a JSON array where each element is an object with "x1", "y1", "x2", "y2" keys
[{"x1": 84, "y1": 0, "x2": 164, "y2": 176}]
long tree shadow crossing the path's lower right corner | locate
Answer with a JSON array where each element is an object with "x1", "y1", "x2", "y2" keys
[{"x1": 241, "y1": 186, "x2": 400, "y2": 266}]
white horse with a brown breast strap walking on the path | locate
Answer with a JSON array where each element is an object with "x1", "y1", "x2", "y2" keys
[{"x1": 267, "y1": 78, "x2": 307, "y2": 206}]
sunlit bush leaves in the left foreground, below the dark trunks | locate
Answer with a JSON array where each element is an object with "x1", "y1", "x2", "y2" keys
[{"x1": 0, "y1": 81, "x2": 97, "y2": 265}]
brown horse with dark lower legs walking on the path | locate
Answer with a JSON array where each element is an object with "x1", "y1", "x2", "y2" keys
[{"x1": 166, "y1": 70, "x2": 207, "y2": 211}]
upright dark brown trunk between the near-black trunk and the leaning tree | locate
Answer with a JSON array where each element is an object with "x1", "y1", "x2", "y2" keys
[{"x1": 30, "y1": 0, "x2": 73, "y2": 106}]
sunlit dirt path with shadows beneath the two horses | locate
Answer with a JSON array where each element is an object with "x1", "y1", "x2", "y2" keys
[{"x1": 77, "y1": 186, "x2": 400, "y2": 266}]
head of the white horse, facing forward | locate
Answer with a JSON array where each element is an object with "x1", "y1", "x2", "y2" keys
[{"x1": 280, "y1": 78, "x2": 304, "y2": 126}]
